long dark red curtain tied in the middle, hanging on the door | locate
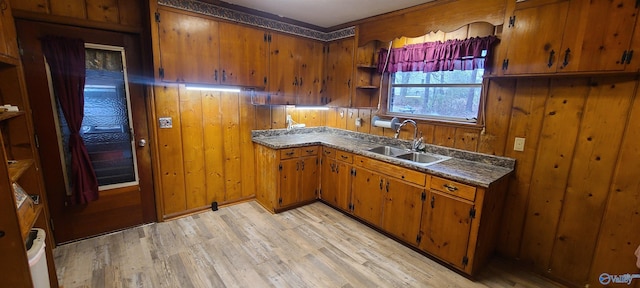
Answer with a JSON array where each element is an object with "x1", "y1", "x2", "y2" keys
[{"x1": 41, "y1": 36, "x2": 98, "y2": 204}]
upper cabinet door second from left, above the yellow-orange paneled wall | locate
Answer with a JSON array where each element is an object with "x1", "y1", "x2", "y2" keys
[{"x1": 218, "y1": 22, "x2": 268, "y2": 87}]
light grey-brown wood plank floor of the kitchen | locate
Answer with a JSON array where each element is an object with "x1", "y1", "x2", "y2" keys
[{"x1": 54, "y1": 202, "x2": 562, "y2": 288}]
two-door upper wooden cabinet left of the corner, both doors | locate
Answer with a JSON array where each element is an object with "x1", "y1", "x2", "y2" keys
[{"x1": 268, "y1": 33, "x2": 323, "y2": 105}]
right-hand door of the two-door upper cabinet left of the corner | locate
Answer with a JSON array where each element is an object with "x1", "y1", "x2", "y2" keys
[{"x1": 296, "y1": 39, "x2": 324, "y2": 105}]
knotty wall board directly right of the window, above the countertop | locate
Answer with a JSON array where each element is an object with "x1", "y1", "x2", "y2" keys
[{"x1": 478, "y1": 79, "x2": 516, "y2": 155}]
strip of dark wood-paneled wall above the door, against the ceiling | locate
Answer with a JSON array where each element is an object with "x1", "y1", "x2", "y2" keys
[{"x1": 11, "y1": 0, "x2": 145, "y2": 30}]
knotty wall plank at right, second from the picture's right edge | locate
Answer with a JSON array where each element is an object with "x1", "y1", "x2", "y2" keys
[{"x1": 551, "y1": 77, "x2": 637, "y2": 283}]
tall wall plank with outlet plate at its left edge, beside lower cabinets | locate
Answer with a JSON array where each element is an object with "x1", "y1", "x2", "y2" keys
[{"x1": 497, "y1": 79, "x2": 549, "y2": 258}]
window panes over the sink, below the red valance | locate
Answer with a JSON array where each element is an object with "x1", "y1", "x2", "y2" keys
[{"x1": 387, "y1": 69, "x2": 484, "y2": 122}]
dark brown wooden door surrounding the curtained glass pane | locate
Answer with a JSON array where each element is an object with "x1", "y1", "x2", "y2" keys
[{"x1": 16, "y1": 19, "x2": 158, "y2": 243}]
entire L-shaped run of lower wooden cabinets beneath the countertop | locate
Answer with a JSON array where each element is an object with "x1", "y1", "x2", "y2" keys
[{"x1": 256, "y1": 145, "x2": 508, "y2": 275}]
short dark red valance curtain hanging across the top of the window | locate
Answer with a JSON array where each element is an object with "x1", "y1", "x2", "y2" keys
[{"x1": 378, "y1": 36, "x2": 498, "y2": 73}]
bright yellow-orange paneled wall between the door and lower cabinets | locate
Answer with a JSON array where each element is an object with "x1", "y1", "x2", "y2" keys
[{"x1": 153, "y1": 85, "x2": 256, "y2": 218}]
